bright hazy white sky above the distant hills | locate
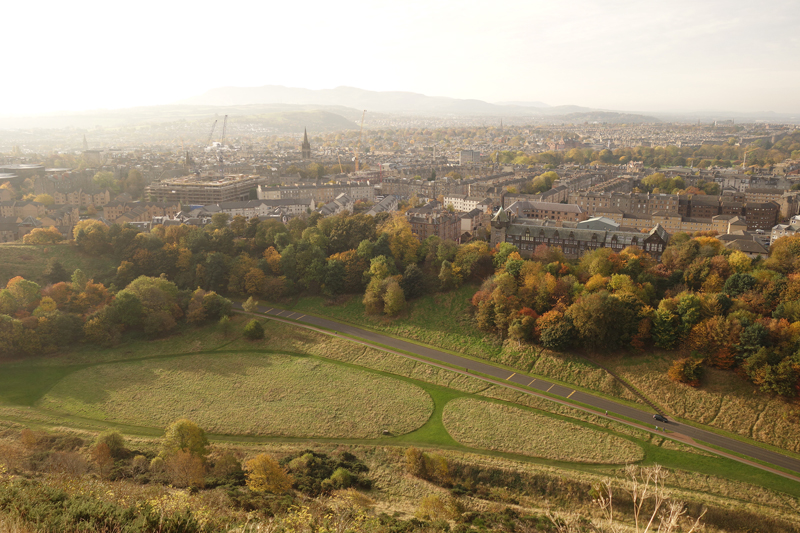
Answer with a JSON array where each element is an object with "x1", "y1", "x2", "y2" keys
[{"x1": 6, "y1": 0, "x2": 800, "y2": 114}]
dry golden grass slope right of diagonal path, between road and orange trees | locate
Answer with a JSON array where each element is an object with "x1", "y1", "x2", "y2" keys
[{"x1": 604, "y1": 354, "x2": 800, "y2": 452}]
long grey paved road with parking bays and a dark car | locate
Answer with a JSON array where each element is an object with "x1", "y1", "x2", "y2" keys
[{"x1": 244, "y1": 306, "x2": 800, "y2": 479}]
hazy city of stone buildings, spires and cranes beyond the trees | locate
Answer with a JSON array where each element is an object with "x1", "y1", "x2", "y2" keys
[{"x1": 0, "y1": 122, "x2": 800, "y2": 255}]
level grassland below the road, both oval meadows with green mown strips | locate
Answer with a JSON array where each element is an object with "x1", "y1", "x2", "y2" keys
[{"x1": 0, "y1": 318, "x2": 800, "y2": 496}]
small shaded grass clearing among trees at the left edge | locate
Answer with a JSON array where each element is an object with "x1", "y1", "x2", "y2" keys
[{"x1": 0, "y1": 244, "x2": 116, "y2": 287}]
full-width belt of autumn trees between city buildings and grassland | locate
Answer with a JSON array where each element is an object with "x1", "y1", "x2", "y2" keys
[{"x1": 0, "y1": 206, "x2": 800, "y2": 397}]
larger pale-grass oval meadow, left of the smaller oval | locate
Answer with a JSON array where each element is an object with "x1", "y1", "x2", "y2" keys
[{"x1": 37, "y1": 354, "x2": 433, "y2": 438}]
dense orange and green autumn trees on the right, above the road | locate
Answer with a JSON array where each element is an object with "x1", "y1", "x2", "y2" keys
[{"x1": 472, "y1": 232, "x2": 800, "y2": 397}]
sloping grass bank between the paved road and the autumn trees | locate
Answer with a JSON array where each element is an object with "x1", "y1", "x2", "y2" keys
[{"x1": 276, "y1": 286, "x2": 800, "y2": 452}]
